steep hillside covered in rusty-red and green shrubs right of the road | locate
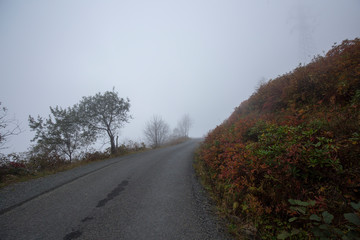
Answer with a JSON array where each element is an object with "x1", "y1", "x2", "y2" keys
[{"x1": 197, "y1": 38, "x2": 360, "y2": 239}]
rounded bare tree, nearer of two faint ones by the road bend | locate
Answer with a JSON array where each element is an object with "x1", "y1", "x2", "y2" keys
[{"x1": 144, "y1": 115, "x2": 169, "y2": 148}]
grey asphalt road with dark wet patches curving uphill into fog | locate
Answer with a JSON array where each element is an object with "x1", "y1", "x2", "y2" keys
[{"x1": 0, "y1": 140, "x2": 229, "y2": 240}]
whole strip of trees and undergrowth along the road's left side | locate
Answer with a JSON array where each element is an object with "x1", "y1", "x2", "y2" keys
[{"x1": 0, "y1": 89, "x2": 191, "y2": 187}]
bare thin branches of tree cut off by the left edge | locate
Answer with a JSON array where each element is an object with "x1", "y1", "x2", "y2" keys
[{"x1": 0, "y1": 102, "x2": 21, "y2": 150}]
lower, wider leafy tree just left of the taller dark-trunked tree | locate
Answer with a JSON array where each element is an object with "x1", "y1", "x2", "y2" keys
[{"x1": 29, "y1": 106, "x2": 94, "y2": 162}]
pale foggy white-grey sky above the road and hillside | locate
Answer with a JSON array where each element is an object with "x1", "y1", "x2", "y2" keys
[{"x1": 0, "y1": 0, "x2": 360, "y2": 151}]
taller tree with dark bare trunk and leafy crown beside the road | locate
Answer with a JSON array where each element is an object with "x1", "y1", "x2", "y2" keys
[{"x1": 79, "y1": 89, "x2": 131, "y2": 154}]
